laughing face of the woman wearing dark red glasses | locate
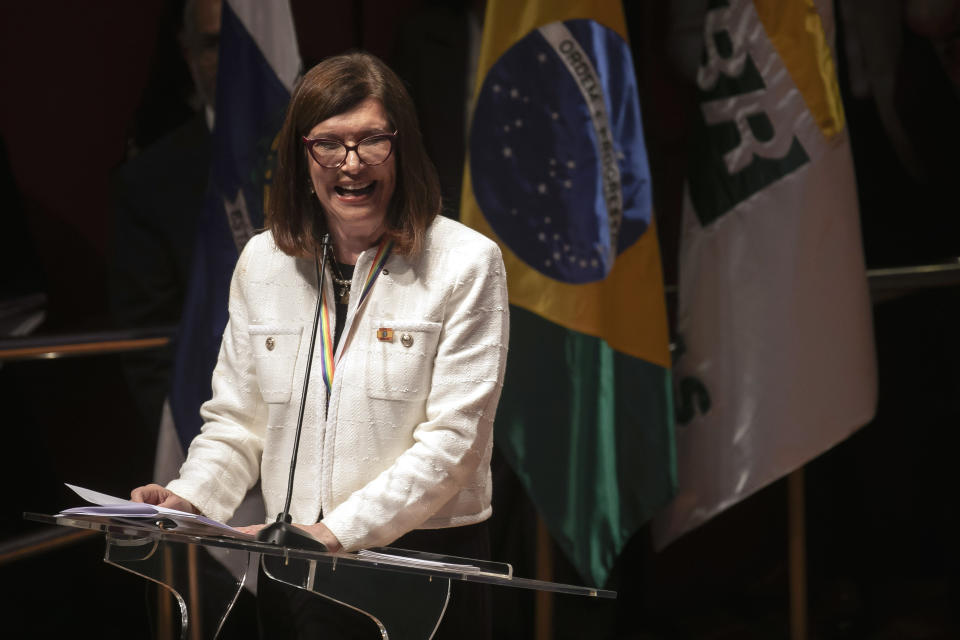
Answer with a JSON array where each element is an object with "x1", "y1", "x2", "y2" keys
[{"x1": 307, "y1": 98, "x2": 397, "y2": 240}]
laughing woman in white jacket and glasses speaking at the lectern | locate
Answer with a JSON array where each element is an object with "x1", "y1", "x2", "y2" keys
[{"x1": 132, "y1": 53, "x2": 509, "y2": 638}]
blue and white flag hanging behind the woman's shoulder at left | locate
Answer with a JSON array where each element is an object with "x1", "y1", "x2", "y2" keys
[{"x1": 170, "y1": 0, "x2": 300, "y2": 449}]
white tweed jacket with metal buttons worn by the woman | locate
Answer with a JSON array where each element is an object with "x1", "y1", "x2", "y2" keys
[{"x1": 168, "y1": 217, "x2": 509, "y2": 550}]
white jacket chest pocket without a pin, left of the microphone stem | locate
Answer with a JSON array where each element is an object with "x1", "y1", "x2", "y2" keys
[{"x1": 248, "y1": 324, "x2": 303, "y2": 403}]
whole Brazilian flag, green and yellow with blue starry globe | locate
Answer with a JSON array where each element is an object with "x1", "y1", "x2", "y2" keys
[{"x1": 461, "y1": 1, "x2": 676, "y2": 586}]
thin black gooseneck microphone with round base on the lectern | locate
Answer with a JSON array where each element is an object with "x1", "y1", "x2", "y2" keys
[{"x1": 257, "y1": 233, "x2": 330, "y2": 551}]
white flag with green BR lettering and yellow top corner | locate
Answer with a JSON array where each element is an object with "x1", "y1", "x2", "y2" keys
[{"x1": 654, "y1": 0, "x2": 876, "y2": 547}]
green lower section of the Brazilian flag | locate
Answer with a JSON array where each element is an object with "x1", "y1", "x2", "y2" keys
[{"x1": 494, "y1": 306, "x2": 676, "y2": 586}]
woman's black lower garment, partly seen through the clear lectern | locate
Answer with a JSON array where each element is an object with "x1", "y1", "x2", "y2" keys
[{"x1": 257, "y1": 522, "x2": 492, "y2": 640}]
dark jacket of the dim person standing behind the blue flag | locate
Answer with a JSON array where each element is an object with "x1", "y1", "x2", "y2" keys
[{"x1": 110, "y1": 115, "x2": 210, "y2": 434}]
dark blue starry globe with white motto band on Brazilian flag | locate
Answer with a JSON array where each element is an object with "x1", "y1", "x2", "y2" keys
[{"x1": 470, "y1": 20, "x2": 651, "y2": 284}]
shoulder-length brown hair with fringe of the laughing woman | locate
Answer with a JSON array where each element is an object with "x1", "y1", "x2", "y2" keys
[{"x1": 266, "y1": 52, "x2": 441, "y2": 257}]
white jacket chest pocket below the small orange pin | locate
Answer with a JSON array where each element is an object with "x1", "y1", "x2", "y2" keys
[{"x1": 366, "y1": 319, "x2": 440, "y2": 400}]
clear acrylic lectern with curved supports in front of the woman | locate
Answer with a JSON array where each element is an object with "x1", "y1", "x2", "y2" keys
[{"x1": 24, "y1": 513, "x2": 616, "y2": 640}]
